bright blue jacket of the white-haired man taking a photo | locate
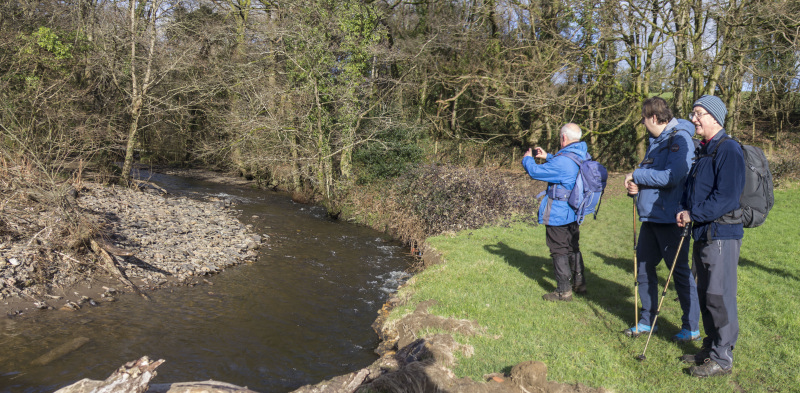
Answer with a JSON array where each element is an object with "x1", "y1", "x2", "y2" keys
[{"x1": 522, "y1": 142, "x2": 589, "y2": 226}]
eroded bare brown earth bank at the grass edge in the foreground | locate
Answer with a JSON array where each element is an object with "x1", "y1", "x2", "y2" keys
[{"x1": 293, "y1": 276, "x2": 607, "y2": 393}]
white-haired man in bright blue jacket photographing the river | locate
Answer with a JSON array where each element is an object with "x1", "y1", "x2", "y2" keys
[{"x1": 522, "y1": 123, "x2": 589, "y2": 301}]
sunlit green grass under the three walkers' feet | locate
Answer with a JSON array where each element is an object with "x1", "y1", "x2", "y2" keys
[{"x1": 393, "y1": 188, "x2": 800, "y2": 393}]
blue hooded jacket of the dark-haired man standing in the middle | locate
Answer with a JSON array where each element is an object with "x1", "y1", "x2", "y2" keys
[{"x1": 633, "y1": 119, "x2": 694, "y2": 224}]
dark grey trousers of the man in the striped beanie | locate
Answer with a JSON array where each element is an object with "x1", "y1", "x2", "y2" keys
[{"x1": 692, "y1": 239, "x2": 742, "y2": 369}]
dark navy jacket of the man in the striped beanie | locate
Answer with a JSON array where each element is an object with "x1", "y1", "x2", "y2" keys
[{"x1": 681, "y1": 130, "x2": 745, "y2": 241}]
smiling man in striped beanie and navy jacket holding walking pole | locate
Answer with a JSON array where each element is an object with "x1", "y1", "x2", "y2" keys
[{"x1": 676, "y1": 95, "x2": 745, "y2": 377}]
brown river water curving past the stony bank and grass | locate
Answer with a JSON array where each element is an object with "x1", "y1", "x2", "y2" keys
[{"x1": 0, "y1": 174, "x2": 411, "y2": 393}]
